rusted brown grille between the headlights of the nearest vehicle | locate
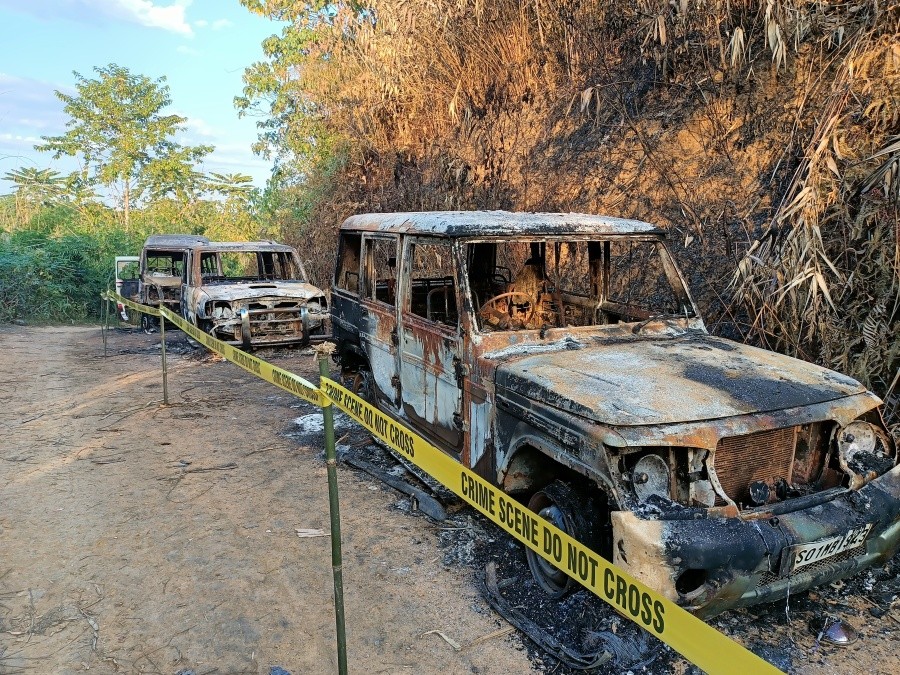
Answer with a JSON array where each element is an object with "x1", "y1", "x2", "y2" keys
[{"x1": 715, "y1": 427, "x2": 796, "y2": 504}]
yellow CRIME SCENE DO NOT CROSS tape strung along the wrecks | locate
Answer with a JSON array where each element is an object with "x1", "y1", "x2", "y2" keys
[{"x1": 105, "y1": 292, "x2": 781, "y2": 674}]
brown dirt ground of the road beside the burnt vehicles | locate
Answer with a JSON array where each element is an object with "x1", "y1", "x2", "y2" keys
[{"x1": 0, "y1": 325, "x2": 900, "y2": 675}]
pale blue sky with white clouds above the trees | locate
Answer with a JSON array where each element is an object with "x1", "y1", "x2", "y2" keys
[{"x1": 0, "y1": 0, "x2": 281, "y2": 195}]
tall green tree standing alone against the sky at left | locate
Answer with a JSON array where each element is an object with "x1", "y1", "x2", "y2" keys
[{"x1": 35, "y1": 63, "x2": 213, "y2": 226}]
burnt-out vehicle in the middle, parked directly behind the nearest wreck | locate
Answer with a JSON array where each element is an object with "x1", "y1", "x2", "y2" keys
[{"x1": 181, "y1": 241, "x2": 330, "y2": 348}]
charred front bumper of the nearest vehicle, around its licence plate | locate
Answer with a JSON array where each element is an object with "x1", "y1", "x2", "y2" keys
[{"x1": 613, "y1": 466, "x2": 900, "y2": 618}]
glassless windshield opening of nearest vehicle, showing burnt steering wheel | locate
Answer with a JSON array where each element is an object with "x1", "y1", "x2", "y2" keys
[{"x1": 467, "y1": 238, "x2": 694, "y2": 331}]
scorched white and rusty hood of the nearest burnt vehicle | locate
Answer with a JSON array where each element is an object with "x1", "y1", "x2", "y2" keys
[{"x1": 496, "y1": 334, "x2": 866, "y2": 426}]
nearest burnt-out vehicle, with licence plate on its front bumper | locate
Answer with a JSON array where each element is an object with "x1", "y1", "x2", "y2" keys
[{"x1": 331, "y1": 212, "x2": 900, "y2": 617}]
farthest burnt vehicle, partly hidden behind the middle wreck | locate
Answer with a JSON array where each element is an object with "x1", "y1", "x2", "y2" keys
[{"x1": 137, "y1": 234, "x2": 209, "y2": 323}]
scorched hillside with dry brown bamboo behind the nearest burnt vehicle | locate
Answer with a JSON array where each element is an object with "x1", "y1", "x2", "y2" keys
[{"x1": 248, "y1": 0, "x2": 900, "y2": 422}]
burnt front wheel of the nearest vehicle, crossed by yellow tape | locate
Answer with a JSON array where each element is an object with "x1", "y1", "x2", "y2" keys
[{"x1": 525, "y1": 480, "x2": 600, "y2": 599}]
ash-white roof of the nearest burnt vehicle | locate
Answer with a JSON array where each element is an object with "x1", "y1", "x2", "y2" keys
[{"x1": 341, "y1": 211, "x2": 665, "y2": 237}]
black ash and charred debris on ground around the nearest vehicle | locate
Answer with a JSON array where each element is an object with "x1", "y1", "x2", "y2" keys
[{"x1": 328, "y1": 432, "x2": 900, "y2": 675}]
